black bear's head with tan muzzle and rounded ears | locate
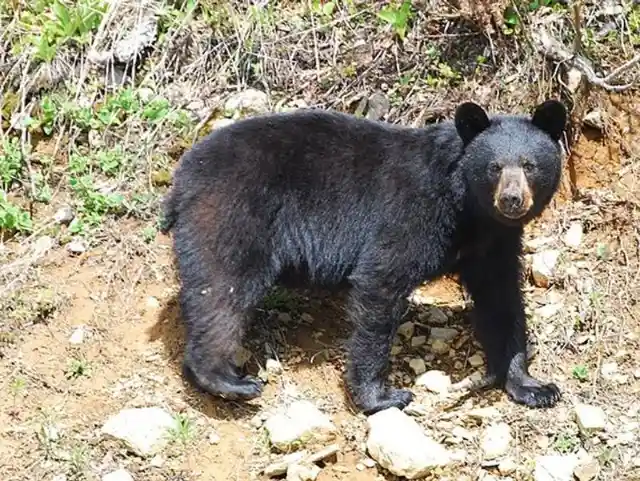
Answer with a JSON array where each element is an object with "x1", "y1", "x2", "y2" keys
[{"x1": 455, "y1": 100, "x2": 567, "y2": 225}]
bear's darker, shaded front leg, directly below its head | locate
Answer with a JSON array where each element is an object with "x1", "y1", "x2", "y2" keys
[{"x1": 460, "y1": 231, "x2": 561, "y2": 407}]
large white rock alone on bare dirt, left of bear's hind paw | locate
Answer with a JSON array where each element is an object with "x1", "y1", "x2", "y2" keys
[{"x1": 102, "y1": 407, "x2": 175, "y2": 457}]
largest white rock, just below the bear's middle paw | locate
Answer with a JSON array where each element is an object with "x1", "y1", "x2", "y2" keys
[{"x1": 367, "y1": 407, "x2": 451, "y2": 479}]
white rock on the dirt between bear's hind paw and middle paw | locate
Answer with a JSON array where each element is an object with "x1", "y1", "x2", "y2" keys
[{"x1": 265, "y1": 401, "x2": 336, "y2": 451}]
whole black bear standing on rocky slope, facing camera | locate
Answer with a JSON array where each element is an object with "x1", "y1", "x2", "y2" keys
[{"x1": 162, "y1": 100, "x2": 567, "y2": 414}]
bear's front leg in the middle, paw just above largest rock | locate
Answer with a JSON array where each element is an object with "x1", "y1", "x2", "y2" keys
[{"x1": 347, "y1": 284, "x2": 413, "y2": 415}]
